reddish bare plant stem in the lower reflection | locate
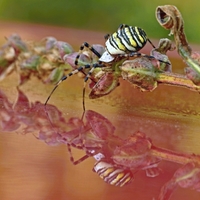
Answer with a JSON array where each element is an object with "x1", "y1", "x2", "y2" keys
[{"x1": 150, "y1": 145, "x2": 200, "y2": 165}]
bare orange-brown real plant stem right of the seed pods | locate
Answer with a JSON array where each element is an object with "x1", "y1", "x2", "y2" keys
[{"x1": 157, "y1": 72, "x2": 200, "y2": 92}]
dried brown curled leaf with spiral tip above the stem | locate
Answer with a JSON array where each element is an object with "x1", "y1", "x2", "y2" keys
[{"x1": 156, "y1": 5, "x2": 200, "y2": 85}]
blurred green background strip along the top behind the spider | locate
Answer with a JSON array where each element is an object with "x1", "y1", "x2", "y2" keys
[{"x1": 0, "y1": 0, "x2": 200, "y2": 43}]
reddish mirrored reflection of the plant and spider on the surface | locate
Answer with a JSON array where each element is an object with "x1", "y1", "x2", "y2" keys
[{"x1": 0, "y1": 89, "x2": 200, "y2": 200}]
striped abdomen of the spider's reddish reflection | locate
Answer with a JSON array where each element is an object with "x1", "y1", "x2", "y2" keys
[{"x1": 93, "y1": 160, "x2": 134, "y2": 187}]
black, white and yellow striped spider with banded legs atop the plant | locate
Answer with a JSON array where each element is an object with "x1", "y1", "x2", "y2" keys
[{"x1": 45, "y1": 24, "x2": 168, "y2": 110}]
